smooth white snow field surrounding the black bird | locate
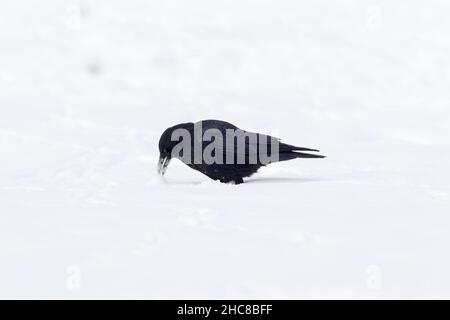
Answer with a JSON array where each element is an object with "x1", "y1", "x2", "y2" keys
[{"x1": 0, "y1": 0, "x2": 450, "y2": 299}]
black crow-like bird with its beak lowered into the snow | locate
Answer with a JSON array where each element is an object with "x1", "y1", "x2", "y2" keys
[{"x1": 158, "y1": 120, "x2": 325, "y2": 184}]
